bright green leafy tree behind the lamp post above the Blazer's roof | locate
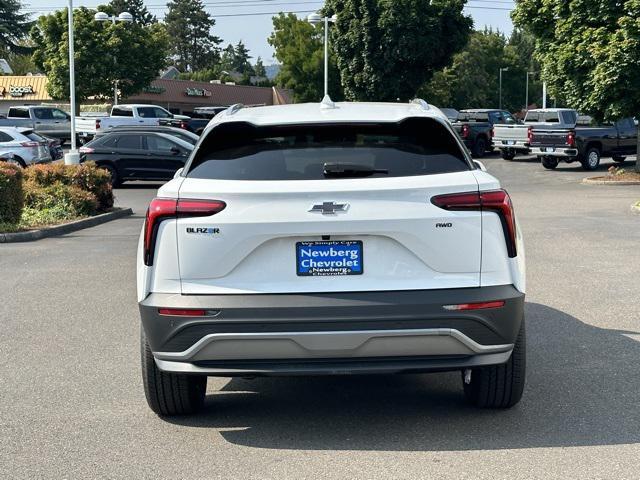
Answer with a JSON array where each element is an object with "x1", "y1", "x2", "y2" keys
[{"x1": 269, "y1": 13, "x2": 343, "y2": 102}]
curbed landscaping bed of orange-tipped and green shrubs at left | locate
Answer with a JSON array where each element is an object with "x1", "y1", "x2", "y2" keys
[{"x1": 0, "y1": 162, "x2": 113, "y2": 233}]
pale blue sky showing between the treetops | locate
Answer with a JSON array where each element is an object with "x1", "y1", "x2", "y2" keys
[{"x1": 23, "y1": 0, "x2": 514, "y2": 65}]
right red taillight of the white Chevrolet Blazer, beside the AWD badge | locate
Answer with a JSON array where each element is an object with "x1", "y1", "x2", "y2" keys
[{"x1": 431, "y1": 190, "x2": 517, "y2": 258}]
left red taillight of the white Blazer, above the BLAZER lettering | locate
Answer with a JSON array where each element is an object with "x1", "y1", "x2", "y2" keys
[{"x1": 144, "y1": 198, "x2": 227, "y2": 266}]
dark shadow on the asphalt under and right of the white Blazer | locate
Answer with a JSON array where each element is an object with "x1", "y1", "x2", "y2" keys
[{"x1": 167, "y1": 303, "x2": 640, "y2": 451}]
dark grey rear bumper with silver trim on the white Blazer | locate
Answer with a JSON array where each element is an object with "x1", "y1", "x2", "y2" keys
[{"x1": 140, "y1": 286, "x2": 524, "y2": 376}]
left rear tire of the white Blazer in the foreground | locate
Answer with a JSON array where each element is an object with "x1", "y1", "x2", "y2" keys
[{"x1": 140, "y1": 330, "x2": 207, "y2": 416}]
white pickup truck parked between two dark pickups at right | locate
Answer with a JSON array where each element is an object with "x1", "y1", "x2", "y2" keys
[{"x1": 493, "y1": 108, "x2": 578, "y2": 160}]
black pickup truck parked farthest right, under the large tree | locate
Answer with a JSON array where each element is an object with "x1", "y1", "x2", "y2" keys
[{"x1": 530, "y1": 118, "x2": 638, "y2": 170}]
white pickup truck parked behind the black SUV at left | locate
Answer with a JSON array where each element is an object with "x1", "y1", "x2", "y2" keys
[{"x1": 76, "y1": 104, "x2": 189, "y2": 143}]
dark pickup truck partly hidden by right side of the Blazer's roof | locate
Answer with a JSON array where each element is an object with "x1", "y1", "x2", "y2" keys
[{"x1": 452, "y1": 109, "x2": 518, "y2": 158}]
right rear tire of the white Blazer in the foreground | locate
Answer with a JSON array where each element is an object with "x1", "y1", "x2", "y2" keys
[{"x1": 462, "y1": 319, "x2": 526, "y2": 408}]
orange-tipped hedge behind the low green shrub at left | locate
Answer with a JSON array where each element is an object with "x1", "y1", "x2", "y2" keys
[{"x1": 25, "y1": 162, "x2": 113, "y2": 212}]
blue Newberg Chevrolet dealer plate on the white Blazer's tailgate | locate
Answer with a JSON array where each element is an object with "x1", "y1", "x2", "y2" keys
[{"x1": 296, "y1": 240, "x2": 364, "y2": 277}]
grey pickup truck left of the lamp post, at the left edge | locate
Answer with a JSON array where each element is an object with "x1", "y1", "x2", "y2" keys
[{"x1": 0, "y1": 105, "x2": 71, "y2": 143}]
